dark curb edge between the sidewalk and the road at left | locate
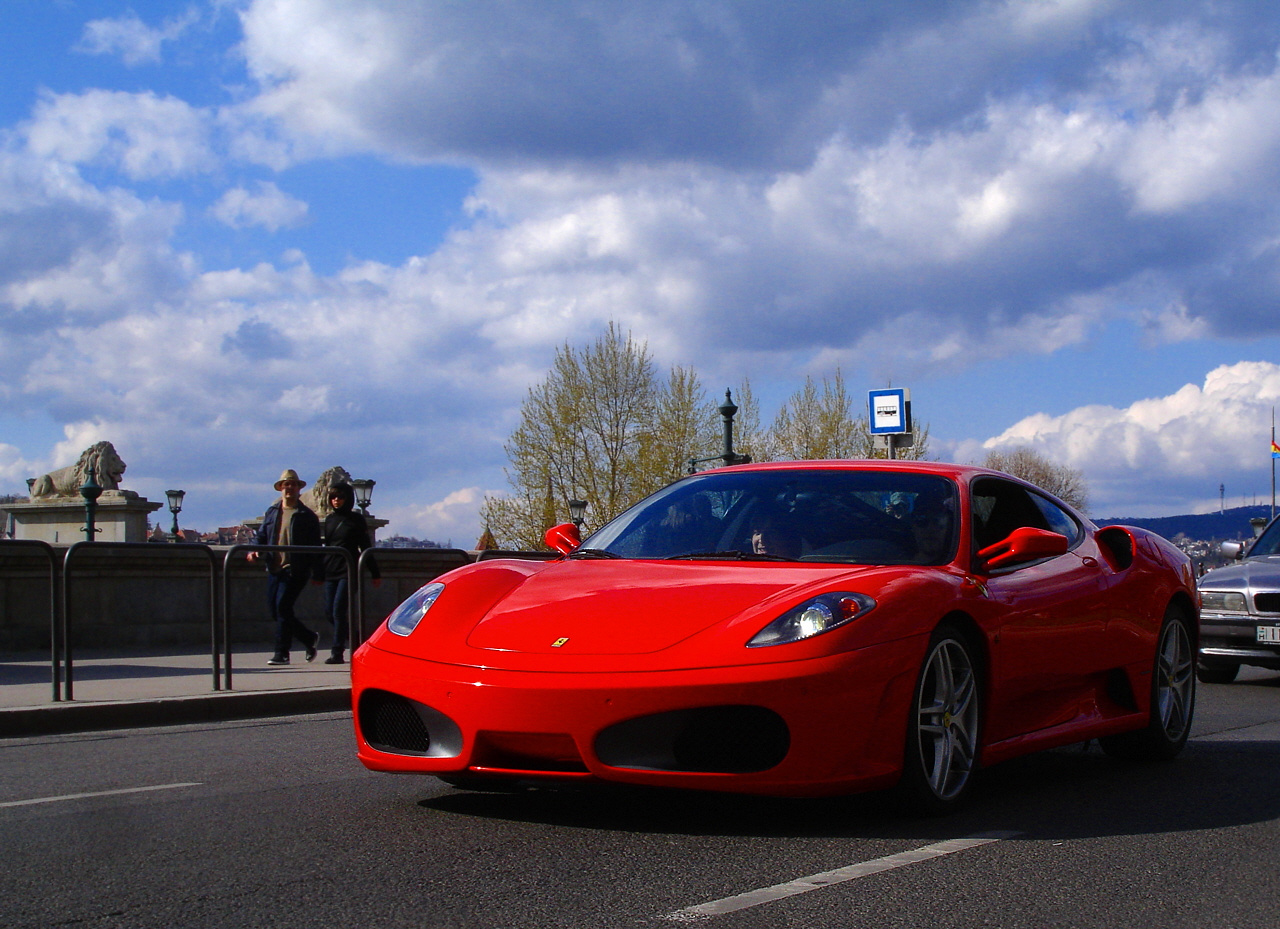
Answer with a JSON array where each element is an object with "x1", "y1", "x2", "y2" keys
[{"x1": 0, "y1": 687, "x2": 351, "y2": 738}]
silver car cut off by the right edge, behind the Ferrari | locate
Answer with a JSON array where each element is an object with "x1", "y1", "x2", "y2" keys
[{"x1": 1196, "y1": 520, "x2": 1280, "y2": 683}]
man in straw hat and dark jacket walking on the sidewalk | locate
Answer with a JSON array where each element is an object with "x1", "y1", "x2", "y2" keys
[{"x1": 248, "y1": 468, "x2": 324, "y2": 668}]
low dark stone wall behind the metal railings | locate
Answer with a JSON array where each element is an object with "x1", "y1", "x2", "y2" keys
[{"x1": 0, "y1": 544, "x2": 474, "y2": 653}]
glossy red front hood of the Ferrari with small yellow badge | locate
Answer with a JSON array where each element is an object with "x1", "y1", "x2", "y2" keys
[{"x1": 370, "y1": 559, "x2": 931, "y2": 671}]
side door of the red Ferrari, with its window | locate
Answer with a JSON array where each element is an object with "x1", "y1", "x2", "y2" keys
[{"x1": 970, "y1": 477, "x2": 1106, "y2": 742}]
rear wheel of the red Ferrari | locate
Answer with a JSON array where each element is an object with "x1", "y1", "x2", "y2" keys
[{"x1": 1098, "y1": 605, "x2": 1197, "y2": 761}]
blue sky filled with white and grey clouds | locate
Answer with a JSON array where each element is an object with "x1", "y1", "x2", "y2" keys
[{"x1": 0, "y1": 0, "x2": 1280, "y2": 545}]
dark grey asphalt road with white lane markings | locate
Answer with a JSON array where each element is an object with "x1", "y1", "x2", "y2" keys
[{"x1": 0, "y1": 672, "x2": 1280, "y2": 929}]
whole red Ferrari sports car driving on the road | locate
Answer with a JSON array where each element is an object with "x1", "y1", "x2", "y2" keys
[{"x1": 351, "y1": 461, "x2": 1199, "y2": 811}]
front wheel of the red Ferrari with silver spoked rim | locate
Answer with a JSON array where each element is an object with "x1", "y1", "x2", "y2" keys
[{"x1": 902, "y1": 626, "x2": 982, "y2": 815}]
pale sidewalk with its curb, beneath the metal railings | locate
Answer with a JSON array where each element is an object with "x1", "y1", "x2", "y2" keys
[{"x1": 0, "y1": 649, "x2": 351, "y2": 738}]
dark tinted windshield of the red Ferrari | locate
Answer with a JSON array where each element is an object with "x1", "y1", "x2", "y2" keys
[{"x1": 582, "y1": 468, "x2": 956, "y2": 564}]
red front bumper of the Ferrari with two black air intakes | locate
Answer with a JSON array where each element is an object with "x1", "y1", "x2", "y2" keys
[{"x1": 352, "y1": 637, "x2": 927, "y2": 796}]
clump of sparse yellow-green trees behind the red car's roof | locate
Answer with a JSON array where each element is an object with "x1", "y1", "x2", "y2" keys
[{"x1": 480, "y1": 340, "x2": 928, "y2": 549}]
